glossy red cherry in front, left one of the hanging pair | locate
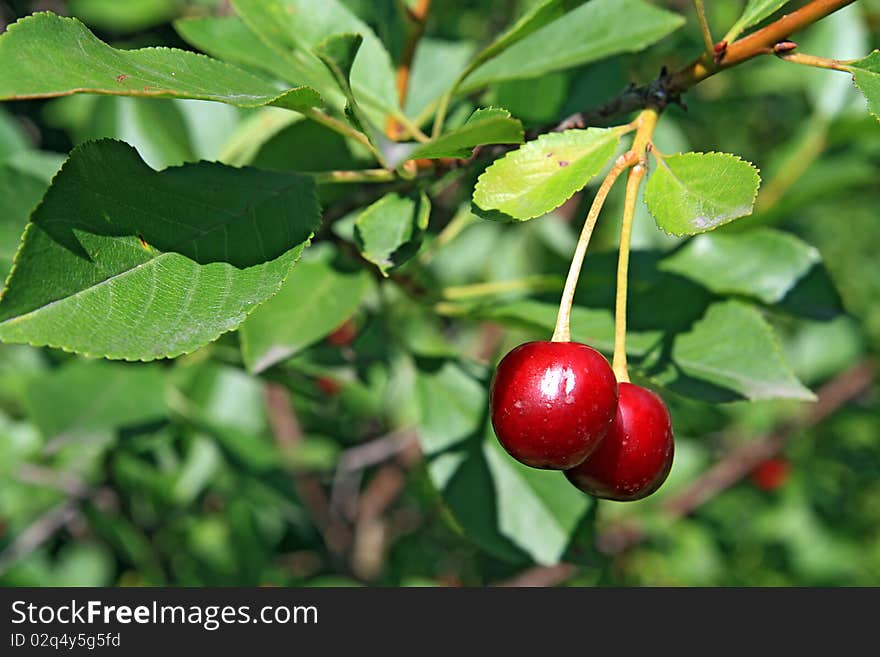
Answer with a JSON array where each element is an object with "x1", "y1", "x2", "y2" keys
[{"x1": 491, "y1": 342, "x2": 617, "y2": 470}]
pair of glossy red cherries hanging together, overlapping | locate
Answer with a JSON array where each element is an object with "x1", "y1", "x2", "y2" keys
[{"x1": 491, "y1": 342, "x2": 674, "y2": 501}]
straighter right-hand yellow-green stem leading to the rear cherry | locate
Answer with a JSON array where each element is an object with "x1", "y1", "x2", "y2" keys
[{"x1": 611, "y1": 108, "x2": 659, "y2": 383}]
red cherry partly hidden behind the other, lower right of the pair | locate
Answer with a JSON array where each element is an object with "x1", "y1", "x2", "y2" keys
[{"x1": 565, "y1": 383, "x2": 675, "y2": 502}]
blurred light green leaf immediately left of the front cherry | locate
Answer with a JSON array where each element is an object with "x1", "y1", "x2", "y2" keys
[{"x1": 416, "y1": 360, "x2": 487, "y2": 455}]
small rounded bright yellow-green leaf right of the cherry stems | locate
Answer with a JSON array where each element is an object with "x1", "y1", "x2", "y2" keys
[{"x1": 645, "y1": 153, "x2": 761, "y2": 235}]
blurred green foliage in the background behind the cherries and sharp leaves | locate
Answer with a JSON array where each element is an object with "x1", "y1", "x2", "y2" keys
[{"x1": 0, "y1": 0, "x2": 880, "y2": 586}]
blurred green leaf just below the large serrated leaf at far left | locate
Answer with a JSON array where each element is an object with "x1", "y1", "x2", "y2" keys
[{"x1": 25, "y1": 360, "x2": 168, "y2": 438}]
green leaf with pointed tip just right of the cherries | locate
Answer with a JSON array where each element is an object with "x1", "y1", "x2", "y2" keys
[{"x1": 660, "y1": 301, "x2": 815, "y2": 401}]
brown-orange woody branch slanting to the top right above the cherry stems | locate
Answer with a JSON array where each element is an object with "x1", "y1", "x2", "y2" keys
[{"x1": 556, "y1": 0, "x2": 855, "y2": 132}]
